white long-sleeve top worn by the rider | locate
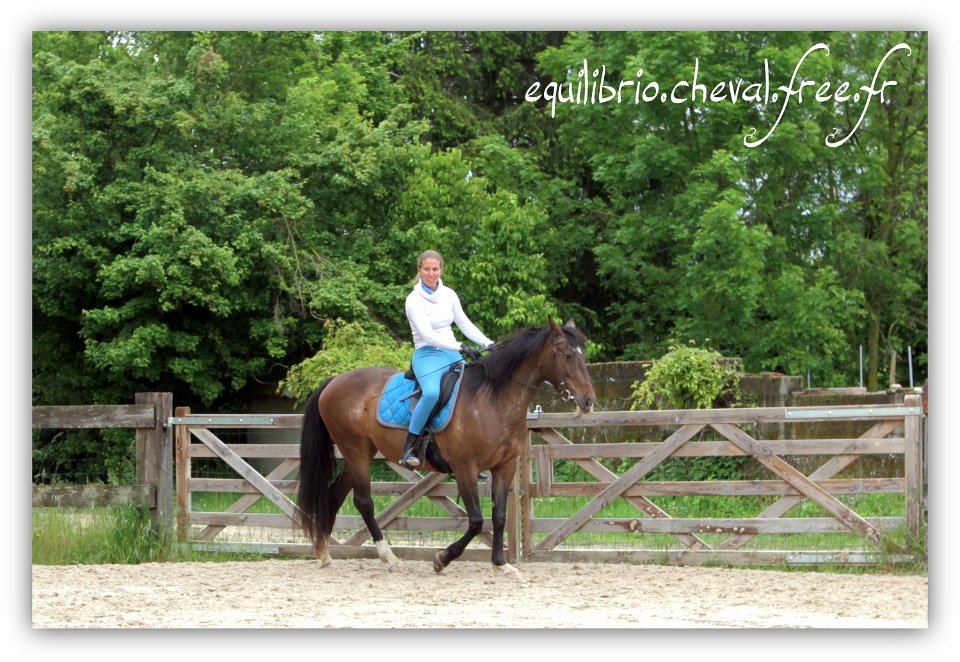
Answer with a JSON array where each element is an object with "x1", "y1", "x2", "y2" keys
[{"x1": 406, "y1": 280, "x2": 493, "y2": 352}]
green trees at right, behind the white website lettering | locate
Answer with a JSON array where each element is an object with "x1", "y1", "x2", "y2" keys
[{"x1": 524, "y1": 32, "x2": 926, "y2": 383}]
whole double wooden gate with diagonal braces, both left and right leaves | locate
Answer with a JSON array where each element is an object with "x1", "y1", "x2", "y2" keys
[{"x1": 171, "y1": 396, "x2": 924, "y2": 564}]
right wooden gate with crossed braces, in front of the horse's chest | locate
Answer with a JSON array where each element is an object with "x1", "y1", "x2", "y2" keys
[{"x1": 521, "y1": 395, "x2": 923, "y2": 564}]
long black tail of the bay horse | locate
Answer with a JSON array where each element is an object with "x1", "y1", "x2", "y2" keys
[{"x1": 297, "y1": 377, "x2": 336, "y2": 550}]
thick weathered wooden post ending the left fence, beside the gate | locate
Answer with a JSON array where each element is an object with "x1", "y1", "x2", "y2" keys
[{"x1": 134, "y1": 393, "x2": 173, "y2": 543}]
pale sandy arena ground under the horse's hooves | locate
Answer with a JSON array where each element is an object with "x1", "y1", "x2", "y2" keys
[{"x1": 32, "y1": 560, "x2": 927, "y2": 628}]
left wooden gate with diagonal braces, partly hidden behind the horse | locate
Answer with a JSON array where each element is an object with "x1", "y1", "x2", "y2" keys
[{"x1": 170, "y1": 408, "x2": 519, "y2": 562}]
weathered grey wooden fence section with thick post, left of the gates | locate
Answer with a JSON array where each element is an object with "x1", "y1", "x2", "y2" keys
[{"x1": 32, "y1": 393, "x2": 173, "y2": 538}]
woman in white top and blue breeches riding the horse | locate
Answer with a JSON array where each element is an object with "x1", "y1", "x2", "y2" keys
[{"x1": 400, "y1": 251, "x2": 493, "y2": 468}]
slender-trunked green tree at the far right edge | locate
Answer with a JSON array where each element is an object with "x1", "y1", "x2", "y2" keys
[{"x1": 828, "y1": 32, "x2": 929, "y2": 390}]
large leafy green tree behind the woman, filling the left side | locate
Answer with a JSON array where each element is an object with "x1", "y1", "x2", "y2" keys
[{"x1": 33, "y1": 32, "x2": 557, "y2": 416}]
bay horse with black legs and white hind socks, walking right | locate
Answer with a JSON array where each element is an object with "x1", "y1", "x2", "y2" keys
[{"x1": 297, "y1": 318, "x2": 596, "y2": 578}]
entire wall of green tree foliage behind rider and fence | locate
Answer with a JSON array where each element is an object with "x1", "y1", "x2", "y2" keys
[{"x1": 32, "y1": 31, "x2": 928, "y2": 420}]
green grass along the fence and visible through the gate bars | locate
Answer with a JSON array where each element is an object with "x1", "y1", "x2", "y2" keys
[{"x1": 33, "y1": 472, "x2": 926, "y2": 574}]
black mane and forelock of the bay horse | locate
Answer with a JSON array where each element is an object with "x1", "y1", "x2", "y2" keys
[{"x1": 464, "y1": 326, "x2": 587, "y2": 395}]
